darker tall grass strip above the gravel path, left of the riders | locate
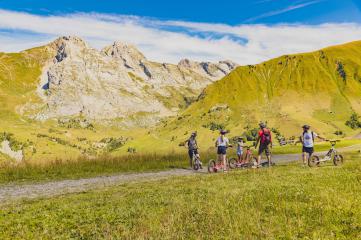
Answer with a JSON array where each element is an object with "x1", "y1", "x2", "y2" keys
[{"x1": 0, "y1": 152, "x2": 214, "y2": 184}]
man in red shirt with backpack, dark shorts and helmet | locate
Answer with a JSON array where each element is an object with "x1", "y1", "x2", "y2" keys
[{"x1": 255, "y1": 123, "x2": 272, "y2": 167}]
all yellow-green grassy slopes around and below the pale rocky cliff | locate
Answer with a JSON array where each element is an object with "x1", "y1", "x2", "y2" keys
[{"x1": 0, "y1": 42, "x2": 361, "y2": 162}]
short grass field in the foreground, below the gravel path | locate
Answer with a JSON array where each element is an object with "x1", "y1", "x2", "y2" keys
[{"x1": 0, "y1": 155, "x2": 361, "y2": 239}]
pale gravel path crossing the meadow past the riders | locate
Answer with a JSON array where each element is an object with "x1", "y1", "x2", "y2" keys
[{"x1": 0, "y1": 145, "x2": 361, "y2": 205}]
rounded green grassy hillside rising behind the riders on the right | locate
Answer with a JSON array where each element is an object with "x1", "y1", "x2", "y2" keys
[{"x1": 152, "y1": 41, "x2": 361, "y2": 150}]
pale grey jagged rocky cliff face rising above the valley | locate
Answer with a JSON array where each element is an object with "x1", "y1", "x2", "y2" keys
[{"x1": 35, "y1": 37, "x2": 236, "y2": 125}]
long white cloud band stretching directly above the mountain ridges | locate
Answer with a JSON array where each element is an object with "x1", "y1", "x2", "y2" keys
[{"x1": 0, "y1": 10, "x2": 361, "y2": 64}]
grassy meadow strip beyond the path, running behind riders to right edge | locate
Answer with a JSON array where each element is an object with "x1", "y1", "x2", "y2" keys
[{"x1": 0, "y1": 137, "x2": 361, "y2": 185}]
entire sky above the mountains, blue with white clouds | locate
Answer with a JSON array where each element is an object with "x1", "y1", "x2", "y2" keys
[{"x1": 0, "y1": 0, "x2": 361, "y2": 64}]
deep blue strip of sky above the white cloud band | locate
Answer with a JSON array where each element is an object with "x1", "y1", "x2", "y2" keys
[{"x1": 0, "y1": 0, "x2": 361, "y2": 25}]
